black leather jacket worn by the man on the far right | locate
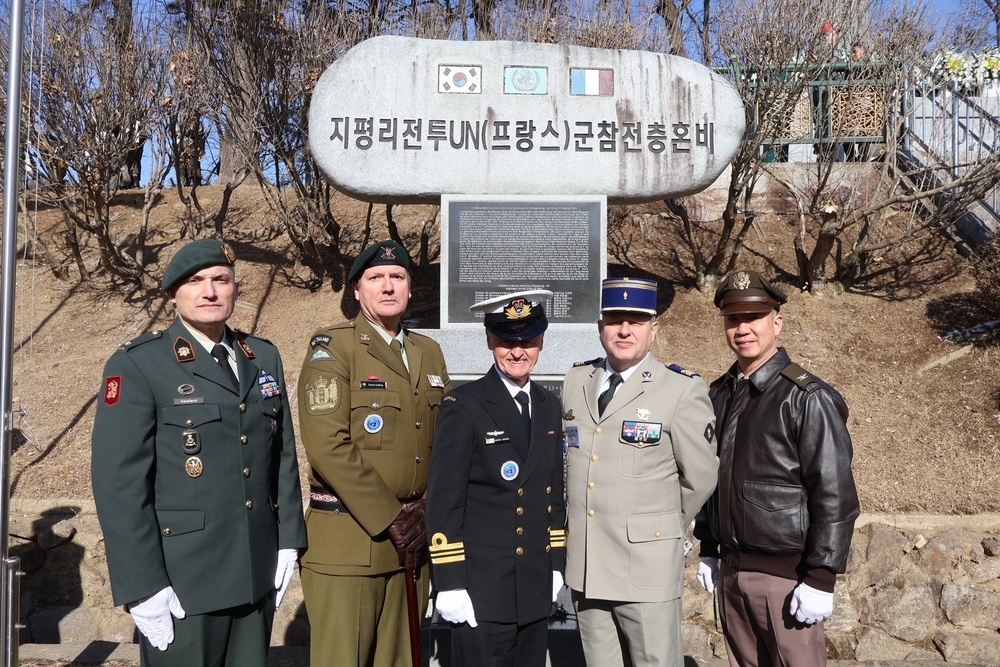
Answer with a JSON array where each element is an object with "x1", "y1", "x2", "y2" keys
[{"x1": 695, "y1": 348, "x2": 860, "y2": 591}]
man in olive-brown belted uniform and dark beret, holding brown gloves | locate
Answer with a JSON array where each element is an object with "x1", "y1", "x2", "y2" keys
[{"x1": 298, "y1": 241, "x2": 450, "y2": 667}]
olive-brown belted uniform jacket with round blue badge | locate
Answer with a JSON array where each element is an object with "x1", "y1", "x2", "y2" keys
[{"x1": 298, "y1": 316, "x2": 451, "y2": 575}]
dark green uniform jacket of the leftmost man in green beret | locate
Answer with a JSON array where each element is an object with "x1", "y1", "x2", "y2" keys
[{"x1": 91, "y1": 319, "x2": 306, "y2": 615}]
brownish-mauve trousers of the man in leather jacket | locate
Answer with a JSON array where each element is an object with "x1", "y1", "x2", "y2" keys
[{"x1": 718, "y1": 560, "x2": 826, "y2": 667}]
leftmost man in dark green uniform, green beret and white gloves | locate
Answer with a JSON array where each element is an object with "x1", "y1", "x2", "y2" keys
[{"x1": 91, "y1": 239, "x2": 306, "y2": 667}]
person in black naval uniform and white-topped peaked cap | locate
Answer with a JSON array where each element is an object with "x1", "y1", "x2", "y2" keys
[{"x1": 427, "y1": 290, "x2": 566, "y2": 667}]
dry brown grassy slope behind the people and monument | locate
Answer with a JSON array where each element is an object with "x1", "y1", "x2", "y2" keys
[{"x1": 10, "y1": 186, "x2": 1000, "y2": 514}]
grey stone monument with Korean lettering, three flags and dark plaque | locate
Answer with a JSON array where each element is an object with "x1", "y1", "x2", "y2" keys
[{"x1": 309, "y1": 36, "x2": 745, "y2": 382}]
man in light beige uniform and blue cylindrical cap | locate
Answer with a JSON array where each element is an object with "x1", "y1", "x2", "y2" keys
[{"x1": 563, "y1": 278, "x2": 719, "y2": 667}]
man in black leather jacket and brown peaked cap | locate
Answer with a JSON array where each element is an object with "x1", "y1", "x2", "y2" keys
[{"x1": 695, "y1": 271, "x2": 859, "y2": 667}]
